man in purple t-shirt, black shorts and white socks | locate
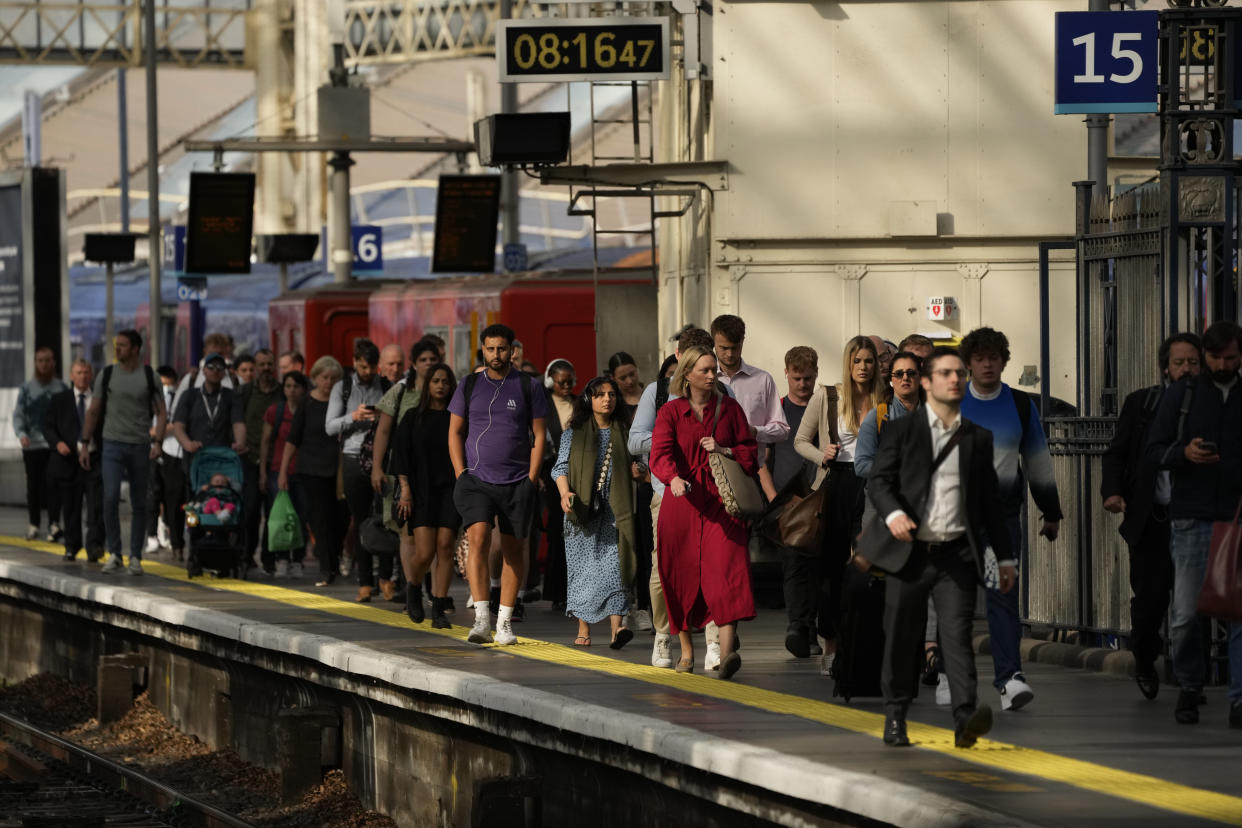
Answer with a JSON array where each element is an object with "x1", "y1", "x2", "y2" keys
[{"x1": 448, "y1": 325, "x2": 546, "y2": 644}]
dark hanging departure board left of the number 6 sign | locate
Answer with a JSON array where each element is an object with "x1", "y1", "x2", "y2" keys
[{"x1": 185, "y1": 173, "x2": 255, "y2": 273}]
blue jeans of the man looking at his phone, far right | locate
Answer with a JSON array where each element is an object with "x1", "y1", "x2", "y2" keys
[{"x1": 1169, "y1": 520, "x2": 1242, "y2": 701}]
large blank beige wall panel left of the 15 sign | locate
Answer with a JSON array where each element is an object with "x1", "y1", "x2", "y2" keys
[{"x1": 714, "y1": 0, "x2": 1086, "y2": 238}]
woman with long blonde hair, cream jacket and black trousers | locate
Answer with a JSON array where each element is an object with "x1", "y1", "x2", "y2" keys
[{"x1": 794, "y1": 336, "x2": 881, "y2": 675}]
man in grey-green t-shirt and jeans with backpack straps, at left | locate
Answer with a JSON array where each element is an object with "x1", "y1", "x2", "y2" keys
[{"x1": 78, "y1": 330, "x2": 168, "y2": 575}]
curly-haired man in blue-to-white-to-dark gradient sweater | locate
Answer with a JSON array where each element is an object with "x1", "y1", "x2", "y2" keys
[{"x1": 959, "y1": 328, "x2": 1062, "y2": 710}]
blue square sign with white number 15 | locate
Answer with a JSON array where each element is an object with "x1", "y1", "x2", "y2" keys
[{"x1": 1054, "y1": 11, "x2": 1160, "y2": 115}]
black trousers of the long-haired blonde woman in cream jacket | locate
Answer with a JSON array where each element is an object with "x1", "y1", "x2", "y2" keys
[{"x1": 814, "y1": 463, "x2": 867, "y2": 641}]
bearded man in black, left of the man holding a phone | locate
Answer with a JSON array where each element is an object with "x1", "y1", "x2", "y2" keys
[{"x1": 1099, "y1": 334, "x2": 1203, "y2": 699}]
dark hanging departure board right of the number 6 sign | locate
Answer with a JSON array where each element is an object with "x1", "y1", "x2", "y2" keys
[{"x1": 431, "y1": 175, "x2": 501, "y2": 273}]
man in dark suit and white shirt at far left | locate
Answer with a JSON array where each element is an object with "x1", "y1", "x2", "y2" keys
[{"x1": 42, "y1": 359, "x2": 104, "y2": 562}]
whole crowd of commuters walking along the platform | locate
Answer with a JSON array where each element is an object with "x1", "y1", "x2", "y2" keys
[{"x1": 14, "y1": 315, "x2": 1242, "y2": 747}]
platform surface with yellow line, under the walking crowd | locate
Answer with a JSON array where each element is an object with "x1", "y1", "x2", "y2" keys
[{"x1": 0, "y1": 509, "x2": 1242, "y2": 828}]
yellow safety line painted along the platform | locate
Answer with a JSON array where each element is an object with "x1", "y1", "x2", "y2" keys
[{"x1": 9, "y1": 535, "x2": 1242, "y2": 826}]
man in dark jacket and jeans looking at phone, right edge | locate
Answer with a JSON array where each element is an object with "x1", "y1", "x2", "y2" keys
[{"x1": 1148, "y1": 322, "x2": 1242, "y2": 729}]
